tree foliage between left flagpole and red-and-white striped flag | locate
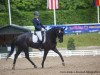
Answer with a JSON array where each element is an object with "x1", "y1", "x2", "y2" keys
[{"x1": 12, "y1": 0, "x2": 46, "y2": 11}]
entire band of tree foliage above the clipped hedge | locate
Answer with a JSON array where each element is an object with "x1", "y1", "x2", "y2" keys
[{"x1": 0, "y1": 0, "x2": 93, "y2": 11}]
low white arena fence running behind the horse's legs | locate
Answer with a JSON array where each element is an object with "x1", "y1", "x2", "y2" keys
[{"x1": 0, "y1": 50, "x2": 100, "y2": 59}]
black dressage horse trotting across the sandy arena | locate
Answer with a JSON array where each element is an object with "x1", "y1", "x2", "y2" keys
[{"x1": 7, "y1": 27, "x2": 65, "y2": 69}]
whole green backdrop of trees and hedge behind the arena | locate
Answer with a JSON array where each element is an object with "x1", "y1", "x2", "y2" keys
[{"x1": 0, "y1": 0, "x2": 97, "y2": 26}]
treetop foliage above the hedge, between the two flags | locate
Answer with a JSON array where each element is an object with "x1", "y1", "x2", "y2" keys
[{"x1": 59, "y1": 0, "x2": 93, "y2": 10}]
